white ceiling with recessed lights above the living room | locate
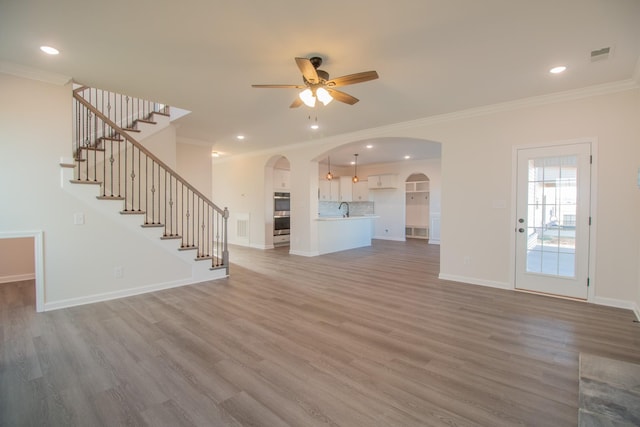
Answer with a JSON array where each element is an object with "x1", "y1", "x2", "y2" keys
[{"x1": 0, "y1": 0, "x2": 640, "y2": 164}]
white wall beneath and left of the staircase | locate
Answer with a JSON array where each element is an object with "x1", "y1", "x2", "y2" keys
[{"x1": 0, "y1": 74, "x2": 215, "y2": 309}]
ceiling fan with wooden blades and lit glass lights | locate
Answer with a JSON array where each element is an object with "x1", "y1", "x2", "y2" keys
[{"x1": 251, "y1": 56, "x2": 378, "y2": 108}]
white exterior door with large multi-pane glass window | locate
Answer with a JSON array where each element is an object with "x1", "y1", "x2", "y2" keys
[{"x1": 515, "y1": 143, "x2": 591, "y2": 299}]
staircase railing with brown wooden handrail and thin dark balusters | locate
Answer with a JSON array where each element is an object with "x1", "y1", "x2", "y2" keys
[{"x1": 65, "y1": 86, "x2": 229, "y2": 275}]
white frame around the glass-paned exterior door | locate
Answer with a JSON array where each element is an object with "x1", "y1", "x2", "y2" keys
[{"x1": 509, "y1": 137, "x2": 598, "y2": 302}]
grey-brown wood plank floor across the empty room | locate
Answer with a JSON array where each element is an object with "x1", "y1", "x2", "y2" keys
[{"x1": 0, "y1": 240, "x2": 640, "y2": 427}]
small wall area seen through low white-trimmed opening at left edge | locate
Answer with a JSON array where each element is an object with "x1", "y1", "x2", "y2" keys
[{"x1": 0, "y1": 237, "x2": 36, "y2": 284}]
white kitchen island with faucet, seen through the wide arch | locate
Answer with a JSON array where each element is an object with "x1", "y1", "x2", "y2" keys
[{"x1": 316, "y1": 215, "x2": 379, "y2": 255}]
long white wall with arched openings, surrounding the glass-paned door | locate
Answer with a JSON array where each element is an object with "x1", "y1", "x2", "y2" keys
[{"x1": 214, "y1": 82, "x2": 640, "y2": 307}]
